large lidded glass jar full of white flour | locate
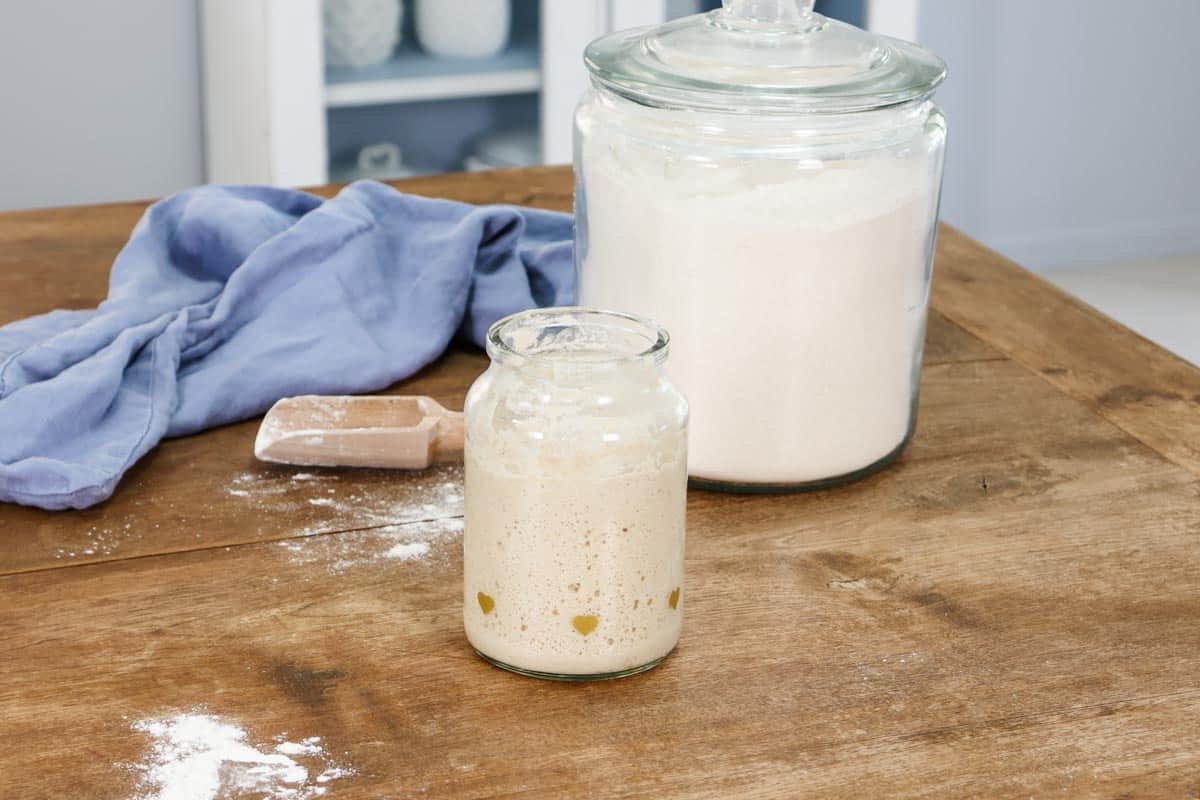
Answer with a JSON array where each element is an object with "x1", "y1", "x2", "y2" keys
[{"x1": 575, "y1": 0, "x2": 946, "y2": 491}]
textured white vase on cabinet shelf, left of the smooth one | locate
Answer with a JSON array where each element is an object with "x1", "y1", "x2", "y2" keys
[{"x1": 322, "y1": 0, "x2": 402, "y2": 70}]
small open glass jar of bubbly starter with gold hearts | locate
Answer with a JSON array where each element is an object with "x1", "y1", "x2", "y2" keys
[{"x1": 463, "y1": 308, "x2": 688, "y2": 680}]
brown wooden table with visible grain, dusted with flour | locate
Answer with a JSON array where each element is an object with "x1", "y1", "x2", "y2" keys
[{"x1": 0, "y1": 169, "x2": 1200, "y2": 800}]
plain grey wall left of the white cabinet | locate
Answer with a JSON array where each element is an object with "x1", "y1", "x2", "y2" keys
[{"x1": 0, "y1": 0, "x2": 204, "y2": 210}]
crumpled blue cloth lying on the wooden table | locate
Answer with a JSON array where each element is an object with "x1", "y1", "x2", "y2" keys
[{"x1": 0, "y1": 181, "x2": 575, "y2": 509}]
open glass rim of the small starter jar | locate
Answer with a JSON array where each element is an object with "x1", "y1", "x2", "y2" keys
[{"x1": 487, "y1": 306, "x2": 671, "y2": 366}]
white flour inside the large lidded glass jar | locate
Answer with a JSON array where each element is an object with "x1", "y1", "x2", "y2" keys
[{"x1": 581, "y1": 126, "x2": 940, "y2": 483}]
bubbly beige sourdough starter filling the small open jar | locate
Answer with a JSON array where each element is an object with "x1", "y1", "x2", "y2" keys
[{"x1": 463, "y1": 450, "x2": 686, "y2": 675}]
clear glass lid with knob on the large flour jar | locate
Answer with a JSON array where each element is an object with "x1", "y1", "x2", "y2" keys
[{"x1": 583, "y1": 0, "x2": 946, "y2": 114}]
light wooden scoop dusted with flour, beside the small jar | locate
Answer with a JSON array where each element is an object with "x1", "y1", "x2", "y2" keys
[{"x1": 254, "y1": 395, "x2": 463, "y2": 469}]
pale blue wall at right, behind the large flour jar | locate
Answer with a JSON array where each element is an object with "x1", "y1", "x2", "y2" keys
[{"x1": 919, "y1": 0, "x2": 1200, "y2": 269}]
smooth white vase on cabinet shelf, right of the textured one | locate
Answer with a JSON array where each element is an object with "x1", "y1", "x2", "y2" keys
[{"x1": 416, "y1": 0, "x2": 512, "y2": 59}]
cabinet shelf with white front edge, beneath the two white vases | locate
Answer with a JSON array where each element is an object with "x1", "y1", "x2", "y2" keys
[{"x1": 325, "y1": 43, "x2": 541, "y2": 108}]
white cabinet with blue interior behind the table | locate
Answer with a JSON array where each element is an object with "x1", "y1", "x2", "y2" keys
[{"x1": 200, "y1": 0, "x2": 892, "y2": 186}]
